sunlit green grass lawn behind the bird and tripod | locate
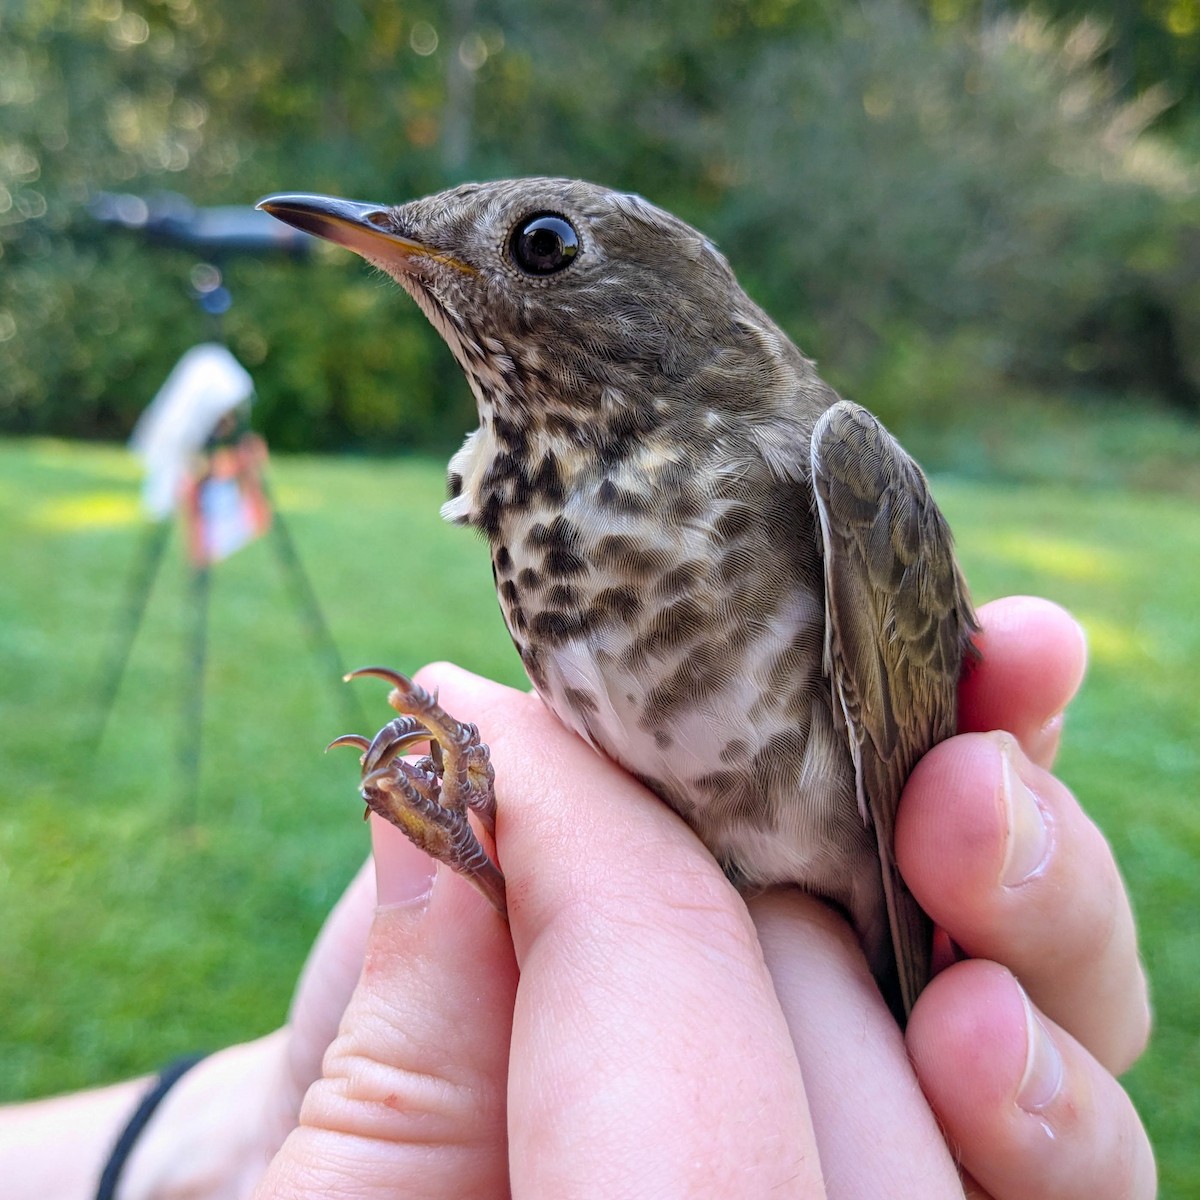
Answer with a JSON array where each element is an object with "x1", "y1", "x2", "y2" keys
[{"x1": 0, "y1": 442, "x2": 1200, "y2": 1196}]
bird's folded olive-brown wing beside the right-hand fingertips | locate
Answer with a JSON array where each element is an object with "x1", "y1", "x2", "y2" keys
[{"x1": 812, "y1": 401, "x2": 978, "y2": 1016}]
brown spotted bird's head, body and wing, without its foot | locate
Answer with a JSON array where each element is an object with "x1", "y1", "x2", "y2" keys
[{"x1": 265, "y1": 179, "x2": 974, "y2": 1012}]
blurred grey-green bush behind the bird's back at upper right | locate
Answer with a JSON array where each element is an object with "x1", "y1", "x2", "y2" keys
[{"x1": 700, "y1": 4, "x2": 1200, "y2": 424}]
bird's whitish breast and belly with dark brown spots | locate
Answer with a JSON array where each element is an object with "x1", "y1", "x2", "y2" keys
[{"x1": 472, "y1": 448, "x2": 875, "y2": 904}]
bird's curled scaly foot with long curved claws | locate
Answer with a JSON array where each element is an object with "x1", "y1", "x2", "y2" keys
[{"x1": 330, "y1": 667, "x2": 506, "y2": 913}]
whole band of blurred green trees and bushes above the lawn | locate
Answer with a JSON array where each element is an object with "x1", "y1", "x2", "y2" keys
[{"x1": 0, "y1": 0, "x2": 1200, "y2": 448}]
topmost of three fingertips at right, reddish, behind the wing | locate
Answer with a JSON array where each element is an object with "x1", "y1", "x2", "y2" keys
[{"x1": 959, "y1": 596, "x2": 1087, "y2": 767}]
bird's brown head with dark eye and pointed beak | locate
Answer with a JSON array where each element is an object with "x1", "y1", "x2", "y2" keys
[{"x1": 259, "y1": 179, "x2": 786, "y2": 451}]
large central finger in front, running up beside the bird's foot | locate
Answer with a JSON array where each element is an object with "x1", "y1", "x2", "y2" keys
[{"x1": 422, "y1": 666, "x2": 823, "y2": 1198}]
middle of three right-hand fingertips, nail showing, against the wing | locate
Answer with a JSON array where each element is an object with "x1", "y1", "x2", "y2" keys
[{"x1": 895, "y1": 733, "x2": 1150, "y2": 1072}]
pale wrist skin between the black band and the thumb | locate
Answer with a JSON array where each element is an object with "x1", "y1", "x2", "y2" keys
[{"x1": 118, "y1": 1030, "x2": 286, "y2": 1200}]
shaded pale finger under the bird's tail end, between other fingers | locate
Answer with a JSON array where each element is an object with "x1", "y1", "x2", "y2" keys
[{"x1": 749, "y1": 889, "x2": 962, "y2": 1200}]
